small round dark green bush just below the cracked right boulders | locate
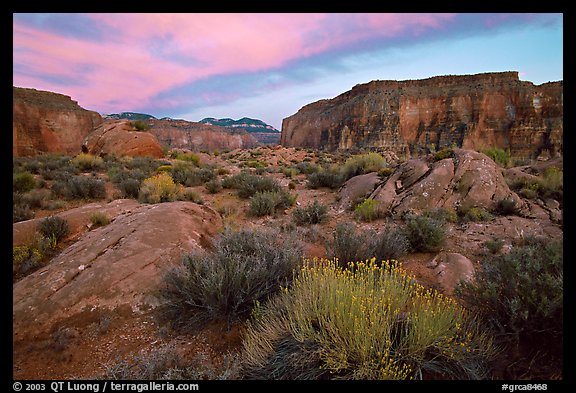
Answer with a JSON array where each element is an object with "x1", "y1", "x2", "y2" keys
[{"x1": 404, "y1": 215, "x2": 446, "y2": 252}]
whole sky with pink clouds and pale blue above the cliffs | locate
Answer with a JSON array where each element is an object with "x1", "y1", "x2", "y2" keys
[{"x1": 12, "y1": 13, "x2": 564, "y2": 130}]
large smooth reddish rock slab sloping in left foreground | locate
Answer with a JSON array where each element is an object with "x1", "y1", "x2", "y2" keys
[{"x1": 12, "y1": 201, "x2": 222, "y2": 341}]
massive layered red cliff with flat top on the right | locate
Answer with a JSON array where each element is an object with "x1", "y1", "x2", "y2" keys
[{"x1": 282, "y1": 72, "x2": 563, "y2": 157}]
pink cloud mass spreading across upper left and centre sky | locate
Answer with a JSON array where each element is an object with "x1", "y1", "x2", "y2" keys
[{"x1": 13, "y1": 13, "x2": 454, "y2": 111}]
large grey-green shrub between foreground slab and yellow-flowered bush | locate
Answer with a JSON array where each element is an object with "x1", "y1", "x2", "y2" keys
[{"x1": 158, "y1": 228, "x2": 302, "y2": 329}]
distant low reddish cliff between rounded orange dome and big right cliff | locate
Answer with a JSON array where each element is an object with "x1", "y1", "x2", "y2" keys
[{"x1": 146, "y1": 119, "x2": 260, "y2": 152}]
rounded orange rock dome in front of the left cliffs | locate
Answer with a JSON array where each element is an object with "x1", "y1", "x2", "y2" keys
[{"x1": 82, "y1": 120, "x2": 164, "y2": 158}]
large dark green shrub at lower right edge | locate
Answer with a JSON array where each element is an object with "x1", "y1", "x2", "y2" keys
[{"x1": 455, "y1": 238, "x2": 563, "y2": 379}]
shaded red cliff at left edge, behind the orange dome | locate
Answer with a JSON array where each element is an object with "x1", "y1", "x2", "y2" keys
[{"x1": 12, "y1": 87, "x2": 102, "y2": 157}]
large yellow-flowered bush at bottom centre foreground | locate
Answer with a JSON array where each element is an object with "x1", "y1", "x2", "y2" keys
[{"x1": 242, "y1": 259, "x2": 493, "y2": 380}]
